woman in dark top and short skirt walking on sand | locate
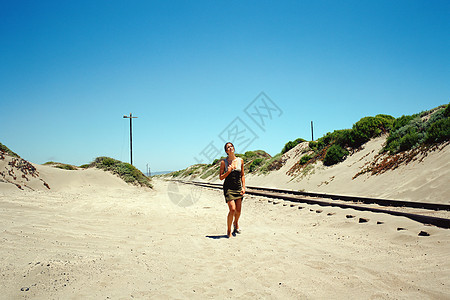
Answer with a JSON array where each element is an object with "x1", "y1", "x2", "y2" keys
[{"x1": 219, "y1": 142, "x2": 245, "y2": 237}]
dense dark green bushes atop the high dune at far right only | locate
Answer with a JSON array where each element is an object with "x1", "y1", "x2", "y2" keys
[{"x1": 289, "y1": 105, "x2": 450, "y2": 174}]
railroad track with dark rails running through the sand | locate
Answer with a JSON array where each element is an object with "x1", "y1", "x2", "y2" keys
[{"x1": 178, "y1": 180, "x2": 450, "y2": 228}]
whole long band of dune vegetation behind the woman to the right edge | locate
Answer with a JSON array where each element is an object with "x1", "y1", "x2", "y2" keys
[{"x1": 166, "y1": 105, "x2": 450, "y2": 179}]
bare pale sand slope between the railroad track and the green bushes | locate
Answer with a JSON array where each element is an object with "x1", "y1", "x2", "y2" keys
[{"x1": 243, "y1": 137, "x2": 450, "y2": 204}]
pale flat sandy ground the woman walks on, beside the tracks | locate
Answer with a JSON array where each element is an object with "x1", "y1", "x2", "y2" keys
[{"x1": 0, "y1": 172, "x2": 450, "y2": 299}]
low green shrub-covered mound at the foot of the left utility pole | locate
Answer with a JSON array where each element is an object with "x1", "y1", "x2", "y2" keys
[{"x1": 90, "y1": 156, "x2": 152, "y2": 188}]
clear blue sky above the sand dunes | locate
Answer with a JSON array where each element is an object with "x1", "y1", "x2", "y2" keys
[{"x1": 0, "y1": 0, "x2": 450, "y2": 171}]
